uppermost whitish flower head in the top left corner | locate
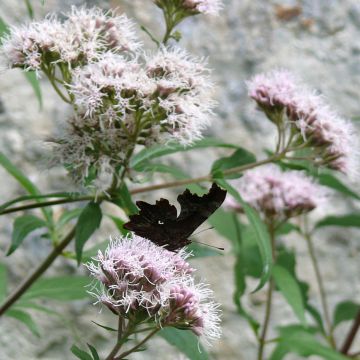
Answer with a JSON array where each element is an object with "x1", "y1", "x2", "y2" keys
[{"x1": 2, "y1": 7, "x2": 139, "y2": 71}]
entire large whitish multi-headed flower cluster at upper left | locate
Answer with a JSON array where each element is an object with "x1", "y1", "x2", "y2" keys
[{"x1": 1, "y1": 7, "x2": 215, "y2": 192}]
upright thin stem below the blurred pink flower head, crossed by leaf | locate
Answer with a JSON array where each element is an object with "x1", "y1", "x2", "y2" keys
[{"x1": 257, "y1": 221, "x2": 276, "y2": 360}]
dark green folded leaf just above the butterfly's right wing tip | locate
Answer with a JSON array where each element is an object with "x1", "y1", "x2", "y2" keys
[{"x1": 211, "y1": 148, "x2": 256, "y2": 179}]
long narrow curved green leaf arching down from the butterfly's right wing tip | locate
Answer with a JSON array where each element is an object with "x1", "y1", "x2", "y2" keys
[{"x1": 217, "y1": 179, "x2": 273, "y2": 292}]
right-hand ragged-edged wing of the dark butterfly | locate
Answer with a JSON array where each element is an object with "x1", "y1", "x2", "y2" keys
[{"x1": 176, "y1": 183, "x2": 226, "y2": 238}]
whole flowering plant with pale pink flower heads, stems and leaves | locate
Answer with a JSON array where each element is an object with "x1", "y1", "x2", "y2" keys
[{"x1": 0, "y1": 0, "x2": 360, "y2": 360}]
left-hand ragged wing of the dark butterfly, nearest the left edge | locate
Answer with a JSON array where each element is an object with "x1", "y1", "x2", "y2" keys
[{"x1": 124, "y1": 199, "x2": 177, "y2": 246}]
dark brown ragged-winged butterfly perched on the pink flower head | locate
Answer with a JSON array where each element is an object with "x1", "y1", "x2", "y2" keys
[{"x1": 124, "y1": 183, "x2": 226, "y2": 251}]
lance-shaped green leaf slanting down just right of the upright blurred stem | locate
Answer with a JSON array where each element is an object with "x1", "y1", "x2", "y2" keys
[{"x1": 272, "y1": 265, "x2": 306, "y2": 326}]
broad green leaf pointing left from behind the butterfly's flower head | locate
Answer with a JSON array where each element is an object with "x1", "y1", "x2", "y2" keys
[{"x1": 22, "y1": 275, "x2": 90, "y2": 301}]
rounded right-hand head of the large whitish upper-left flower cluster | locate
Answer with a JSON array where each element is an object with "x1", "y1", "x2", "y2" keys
[{"x1": 146, "y1": 47, "x2": 215, "y2": 145}]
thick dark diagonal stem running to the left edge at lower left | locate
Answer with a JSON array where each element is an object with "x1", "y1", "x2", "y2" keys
[{"x1": 0, "y1": 227, "x2": 75, "y2": 316}]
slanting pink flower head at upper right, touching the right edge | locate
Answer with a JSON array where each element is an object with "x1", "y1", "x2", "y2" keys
[{"x1": 247, "y1": 70, "x2": 359, "y2": 176}]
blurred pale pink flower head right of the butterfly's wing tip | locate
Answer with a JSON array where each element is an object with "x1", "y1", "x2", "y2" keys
[{"x1": 226, "y1": 164, "x2": 328, "y2": 221}]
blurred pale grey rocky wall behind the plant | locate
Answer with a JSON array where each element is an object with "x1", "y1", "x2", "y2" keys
[{"x1": 0, "y1": 0, "x2": 360, "y2": 360}]
